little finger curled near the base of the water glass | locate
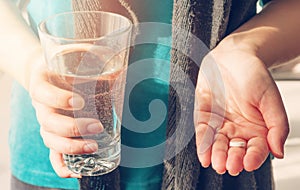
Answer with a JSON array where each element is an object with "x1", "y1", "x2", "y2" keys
[{"x1": 49, "y1": 150, "x2": 81, "y2": 178}]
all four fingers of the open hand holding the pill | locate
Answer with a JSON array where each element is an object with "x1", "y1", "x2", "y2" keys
[{"x1": 196, "y1": 124, "x2": 269, "y2": 176}]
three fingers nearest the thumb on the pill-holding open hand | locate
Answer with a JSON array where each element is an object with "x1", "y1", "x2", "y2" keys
[{"x1": 212, "y1": 134, "x2": 269, "y2": 176}]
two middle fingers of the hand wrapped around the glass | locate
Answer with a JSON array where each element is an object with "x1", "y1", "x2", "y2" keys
[{"x1": 34, "y1": 96, "x2": 98, "y2": 154}]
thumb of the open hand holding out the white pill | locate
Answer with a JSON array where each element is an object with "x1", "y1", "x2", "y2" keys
[{"x1": 259, "y1": 83, "x2": 289, "y2": 158}]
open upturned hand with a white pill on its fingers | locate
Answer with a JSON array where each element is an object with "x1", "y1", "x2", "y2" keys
[{"x1": 194, "y1": 47, "x2": 289, "y2": 175}]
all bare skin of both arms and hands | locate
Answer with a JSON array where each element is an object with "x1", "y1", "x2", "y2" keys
[{"x1": 0, "y1": 0, "x2": 300, "y2": 177}]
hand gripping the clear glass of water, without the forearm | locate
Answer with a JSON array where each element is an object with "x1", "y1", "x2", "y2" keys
[{"x1": 29, "y1": 59, "x2": 103, "y2": 177}]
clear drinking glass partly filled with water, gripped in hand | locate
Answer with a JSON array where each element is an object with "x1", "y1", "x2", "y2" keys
[{"x1": 38, "y1": 11, "x2": 132, "y2": 176}]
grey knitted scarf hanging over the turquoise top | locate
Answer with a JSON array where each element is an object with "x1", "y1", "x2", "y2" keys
[{"x1": 73, "y1": 0, "x2": 273, "y2": 190}]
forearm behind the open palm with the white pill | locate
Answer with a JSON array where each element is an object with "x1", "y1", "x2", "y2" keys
[{"x1": 221, "y1": 0, "x2": 300, "y2": 67}]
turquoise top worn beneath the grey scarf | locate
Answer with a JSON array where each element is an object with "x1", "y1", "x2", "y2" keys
[{"x1": 9, "y1": 0, "x2": 173, "y2": 190}]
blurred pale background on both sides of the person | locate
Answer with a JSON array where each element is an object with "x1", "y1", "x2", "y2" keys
[{"x1": 0, "y1": 58, "x2": 300, "y2": 190}]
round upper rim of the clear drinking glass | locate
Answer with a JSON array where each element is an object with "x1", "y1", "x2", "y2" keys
[{"x1": 37, "y1": 11, "x2": 133, "y2": 42}]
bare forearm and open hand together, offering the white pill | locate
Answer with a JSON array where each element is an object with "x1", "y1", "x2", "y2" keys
[{"x1": 195, "y1": 0, "x2": 300, "y2": 175}]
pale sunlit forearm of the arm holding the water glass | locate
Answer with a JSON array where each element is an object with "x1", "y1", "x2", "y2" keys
[{"x1": 0, "y1": 0, "x2": 41, "y2": 88}]
